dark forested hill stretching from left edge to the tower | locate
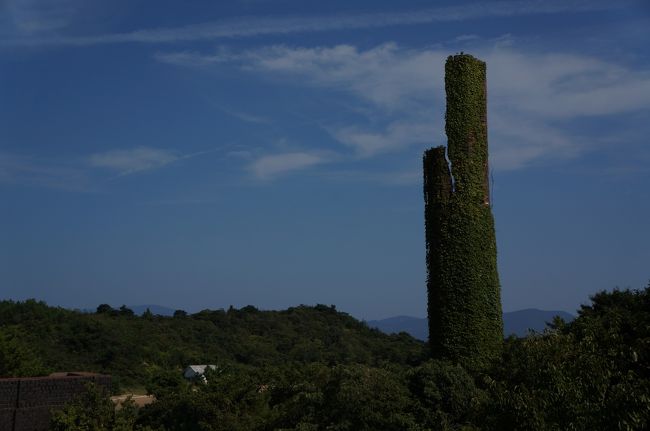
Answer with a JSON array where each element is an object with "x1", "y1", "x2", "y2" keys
[{"x1": 0, "y1": 300, "x2": 424, "y2": 387}]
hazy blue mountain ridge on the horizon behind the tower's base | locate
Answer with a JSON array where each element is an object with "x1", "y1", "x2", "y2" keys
[{"x1": 366, "y1": 308, "x2": 574, "y2": 340}]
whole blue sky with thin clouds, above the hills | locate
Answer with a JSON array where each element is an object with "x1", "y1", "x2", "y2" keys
[{"x1": 0, "y1": 0, "x2": 650, "y2": 319}]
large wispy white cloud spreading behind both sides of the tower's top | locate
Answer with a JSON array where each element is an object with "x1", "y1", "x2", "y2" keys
[{"x1": 163, "y1": 42, "x2": 650, "y2": 169}]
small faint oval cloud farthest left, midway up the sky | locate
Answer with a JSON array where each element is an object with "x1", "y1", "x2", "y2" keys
[{"x1": 88, "y1": 147, "x2": 177, "y2": 175}]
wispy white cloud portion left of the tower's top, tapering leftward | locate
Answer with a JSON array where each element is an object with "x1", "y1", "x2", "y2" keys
[{"x1": 157, "y1": 43, "x2": 446, "y2": 157}]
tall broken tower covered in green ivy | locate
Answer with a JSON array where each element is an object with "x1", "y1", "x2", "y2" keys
[{"x1": 423, "y1": 53, "x2": 503, "y2": 370}]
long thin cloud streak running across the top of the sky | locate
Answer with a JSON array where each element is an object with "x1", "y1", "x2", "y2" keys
[{"x1": 4, "y1": 0, "x2": 622, "y2": 46}]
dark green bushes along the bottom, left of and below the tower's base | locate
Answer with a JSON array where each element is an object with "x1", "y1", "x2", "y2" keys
[{"x1": 138, "y1": 362, "x2": 484, "y2": 431}]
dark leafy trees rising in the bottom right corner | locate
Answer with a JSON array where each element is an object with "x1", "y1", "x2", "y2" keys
[{"x1": 486, "y1": 289, "x2": 650, "y2": 430}]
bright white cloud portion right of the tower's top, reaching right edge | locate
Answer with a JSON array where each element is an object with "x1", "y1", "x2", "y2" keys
[{"x1": 485, "y1": 49, "x2": 650, "y2": 119}]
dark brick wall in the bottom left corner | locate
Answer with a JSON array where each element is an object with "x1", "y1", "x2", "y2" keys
[{"x1": 0, "y1": 373, "x2": 111, "y2": 431}]
